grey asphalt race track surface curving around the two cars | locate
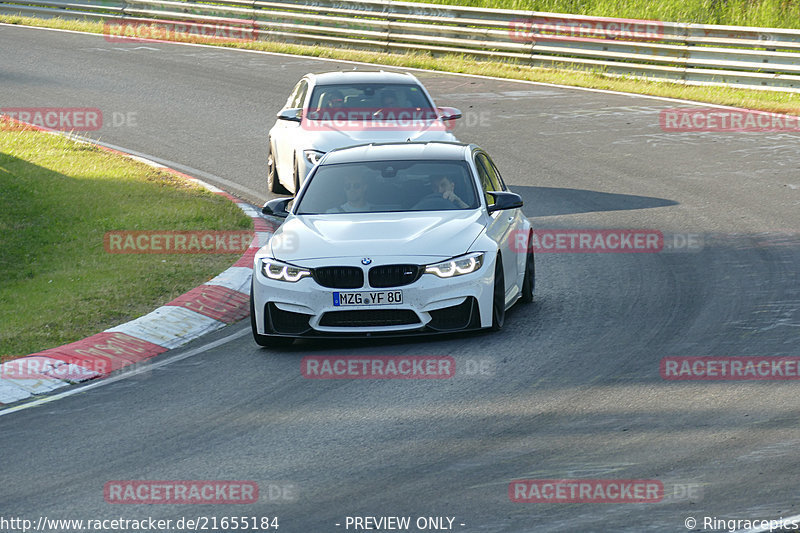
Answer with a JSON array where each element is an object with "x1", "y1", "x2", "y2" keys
[{"x1": 0, "y1": 26, "x2": 800, "y2": 533}]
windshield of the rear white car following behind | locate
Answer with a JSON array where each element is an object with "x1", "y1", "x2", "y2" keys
[{"x1": 308, "y1": 83, "x2": 437, "y2": 120}]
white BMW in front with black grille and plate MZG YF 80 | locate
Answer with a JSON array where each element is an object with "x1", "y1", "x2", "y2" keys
[{"x1": 250, "y1": 142, "x2": 535, "y2": 346}]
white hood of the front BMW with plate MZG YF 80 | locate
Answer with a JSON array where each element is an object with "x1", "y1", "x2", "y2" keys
[{"x1": 270, "y1": 210, "x2": 484, "y2": 262}]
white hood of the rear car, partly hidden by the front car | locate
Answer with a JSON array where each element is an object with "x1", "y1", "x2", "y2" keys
[{"x1": 305, "y1": 121, "x2": 457, "y2": 152}]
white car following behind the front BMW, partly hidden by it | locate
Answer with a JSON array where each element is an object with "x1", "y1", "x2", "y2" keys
[{"x1": 267, "y1": 71, "x2": 461, "y2": 194}]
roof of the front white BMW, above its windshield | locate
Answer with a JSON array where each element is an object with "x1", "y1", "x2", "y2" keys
[{"x1": 324, "y1": 141, "x2": 477, "y2": 165}]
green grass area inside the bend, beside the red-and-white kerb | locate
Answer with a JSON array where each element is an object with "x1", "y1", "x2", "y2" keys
[{"x1": 0, "y1": 123, "x2": 252, "y2": 359}]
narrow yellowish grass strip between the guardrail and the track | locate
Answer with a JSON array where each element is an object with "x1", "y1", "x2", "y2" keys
[{"x1": 0, "y1": 15, "x2": 800, "y2": 115}]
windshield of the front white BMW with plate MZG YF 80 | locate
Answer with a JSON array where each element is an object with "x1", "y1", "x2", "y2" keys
[{"x1": 295, "y1": 161, "x2": 479, "y2": 215}]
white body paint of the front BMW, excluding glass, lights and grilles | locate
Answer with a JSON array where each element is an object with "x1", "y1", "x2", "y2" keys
[{"x1": 252, "y1": 142, "x2": 531, "y2": 337}]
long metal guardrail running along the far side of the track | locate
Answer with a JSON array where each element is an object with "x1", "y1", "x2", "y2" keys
[{"x1": 0, "y1": 0, "x2": 800, "y2": 92}]
